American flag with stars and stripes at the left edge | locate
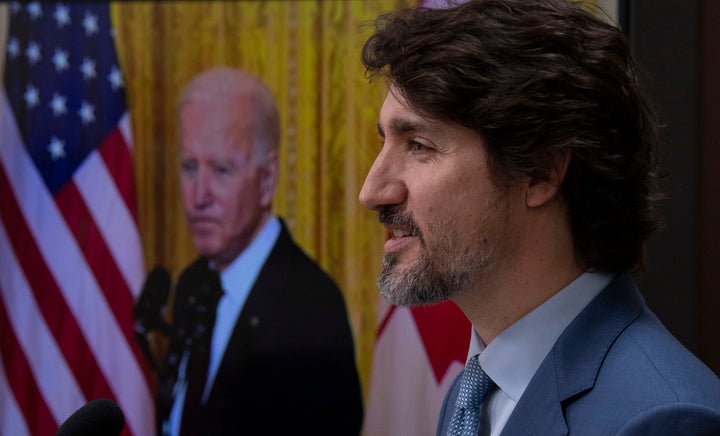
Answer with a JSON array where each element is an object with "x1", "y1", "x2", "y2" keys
[{"x1": 0, "y1": 2, "x2": 155, "y2": 435}]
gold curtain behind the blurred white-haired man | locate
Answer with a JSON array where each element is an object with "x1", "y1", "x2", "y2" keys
[{"x1": 111, "y1": 0, "x2": 413, "y2": 402}]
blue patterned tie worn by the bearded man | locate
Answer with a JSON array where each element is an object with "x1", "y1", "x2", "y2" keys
[{"x1": 448, "y1": 356, "x2": 494, "y2": 436}]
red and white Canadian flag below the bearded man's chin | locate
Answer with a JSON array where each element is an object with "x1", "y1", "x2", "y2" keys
[{"x1": 364, "y1": 298, "x2": 471, "y2": 436}]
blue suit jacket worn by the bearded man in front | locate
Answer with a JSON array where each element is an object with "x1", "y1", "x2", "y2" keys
[{"x1": 438, "y1": 274, "x2": 720, "y2": 436}]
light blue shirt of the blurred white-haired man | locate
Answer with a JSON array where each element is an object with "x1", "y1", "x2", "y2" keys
[{"x1": 163, "y1": 215, "x2": 281, "y2": 436}]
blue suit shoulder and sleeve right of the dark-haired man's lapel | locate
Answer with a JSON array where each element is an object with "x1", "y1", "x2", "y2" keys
[{"x1": 564, "y1": 310, "x2": 720, "y2": 435}]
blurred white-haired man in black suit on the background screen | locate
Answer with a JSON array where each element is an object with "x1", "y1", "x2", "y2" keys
[{"x1": 143, "y1": 67, "x2": 362, "y2": 435}]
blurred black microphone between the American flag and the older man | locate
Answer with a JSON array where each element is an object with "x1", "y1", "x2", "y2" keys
[{"x1": 133, "y1": 265, "x2": 172, "y2": 368}]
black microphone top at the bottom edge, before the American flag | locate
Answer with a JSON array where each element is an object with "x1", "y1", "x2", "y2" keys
[{"x1": 56, "y1": 398, "x2": 125, "y2": 436}]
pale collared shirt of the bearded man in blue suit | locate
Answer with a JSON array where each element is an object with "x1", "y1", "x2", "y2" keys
[{"x1": 468, "y1": 272, "x2": 614, "y2": 436}]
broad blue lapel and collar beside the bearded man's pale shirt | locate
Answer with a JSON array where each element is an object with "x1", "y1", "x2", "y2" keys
[{"x1": 502, "y1": 274, "x2": 644, "y2": 436}]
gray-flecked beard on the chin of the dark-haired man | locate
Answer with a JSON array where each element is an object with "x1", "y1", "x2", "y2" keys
[{"x1": 378, "y1": 249, "x2": 471, "y2": 306}]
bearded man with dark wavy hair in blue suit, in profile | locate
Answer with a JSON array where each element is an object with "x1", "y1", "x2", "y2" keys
[{"x1": 360, "y1": 0, "x2": 720, "y2": 435}]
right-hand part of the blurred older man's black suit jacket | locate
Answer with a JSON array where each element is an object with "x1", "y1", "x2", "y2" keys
[{"x1": 172, "y1": 223, "x2": 363, "y2": 435}]
